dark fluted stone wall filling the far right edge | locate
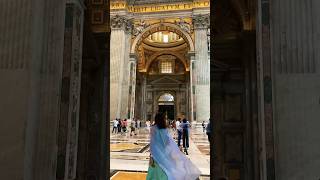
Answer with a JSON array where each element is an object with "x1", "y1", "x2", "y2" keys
[{"x1": 271, "y1": 0, "x2": 320, "y2": 180}]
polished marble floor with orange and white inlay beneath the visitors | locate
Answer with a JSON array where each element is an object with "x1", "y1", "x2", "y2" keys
[{"x1": 110, "y1": 128, "x2": 210, "y2": 180}]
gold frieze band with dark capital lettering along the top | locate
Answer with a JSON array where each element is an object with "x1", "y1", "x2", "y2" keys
[{"x1": 110, "y1": 0, "x2": 210, "y2": 13}]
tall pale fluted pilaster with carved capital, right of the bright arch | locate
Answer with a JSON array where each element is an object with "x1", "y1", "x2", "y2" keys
[{"x1": 193, "y1": 14, "x2": 210, "y2": 122}]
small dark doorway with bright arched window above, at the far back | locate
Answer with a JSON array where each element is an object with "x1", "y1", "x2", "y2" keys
[{"x1": 158, "y1": 93, "x2": 175, "y2": 120}]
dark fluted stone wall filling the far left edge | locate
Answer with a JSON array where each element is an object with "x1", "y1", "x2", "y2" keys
[{"x1": 0, "y1": 0, "x2": 65, "y2": 180}]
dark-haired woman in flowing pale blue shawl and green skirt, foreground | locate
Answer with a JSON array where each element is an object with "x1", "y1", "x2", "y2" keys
[{"x1": 147, "y1": 114, "x2": 201, "y2": 180}]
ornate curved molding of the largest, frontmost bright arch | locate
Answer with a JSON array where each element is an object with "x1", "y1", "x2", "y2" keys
[{"x1": 130, "y1": 22, "x2": 194, "y2": 54}]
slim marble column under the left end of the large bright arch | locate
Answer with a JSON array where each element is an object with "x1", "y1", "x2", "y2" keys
[{"x1": 129, "y1": 56, "x2": 137, "y2": 119}]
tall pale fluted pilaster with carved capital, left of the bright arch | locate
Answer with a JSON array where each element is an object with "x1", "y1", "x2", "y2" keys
[{"x1": 110, "y1": 15, "x2": 130, "y2": 119}]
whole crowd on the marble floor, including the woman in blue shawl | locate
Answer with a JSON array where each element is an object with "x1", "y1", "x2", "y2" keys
[{"x1": 112, "y1": 114, "x2": 211, "y2": 180}]
